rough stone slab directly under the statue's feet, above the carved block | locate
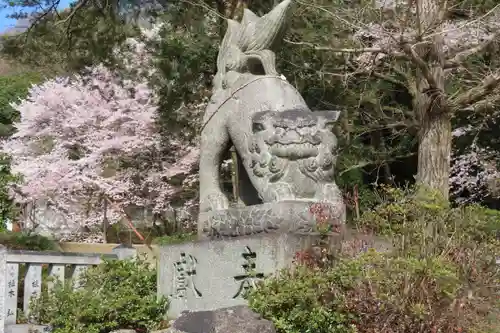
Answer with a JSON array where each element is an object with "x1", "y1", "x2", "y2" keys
[{"x1": 198, "y1": 201, "x2": 345, "y2": 239}]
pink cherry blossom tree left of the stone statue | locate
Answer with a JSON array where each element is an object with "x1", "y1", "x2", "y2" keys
[{"x1": 3, "y1": 25, "x2": 198, "y2": 237}]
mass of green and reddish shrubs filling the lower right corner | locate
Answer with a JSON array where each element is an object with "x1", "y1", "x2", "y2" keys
[{"x1": 248, "y1": 188, "x2": 500, "y2": 333}]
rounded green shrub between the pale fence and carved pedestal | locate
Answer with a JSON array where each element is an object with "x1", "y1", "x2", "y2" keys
[{"x1": 31, "y1": 259, "x2": 168, "y2": 333}]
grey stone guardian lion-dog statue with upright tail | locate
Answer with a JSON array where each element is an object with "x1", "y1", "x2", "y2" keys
[{"x1": 199, "y1": 0, "x2": 344, "y2": 235}]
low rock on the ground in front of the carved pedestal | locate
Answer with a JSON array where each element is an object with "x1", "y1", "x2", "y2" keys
[{"x1": 171, "y1": 305, "x2": 276, "y2": 333}]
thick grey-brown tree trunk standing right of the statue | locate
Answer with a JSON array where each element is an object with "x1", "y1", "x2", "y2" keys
[{"x1": 415, "y1": 0, "x2": 451, "y2": 200}]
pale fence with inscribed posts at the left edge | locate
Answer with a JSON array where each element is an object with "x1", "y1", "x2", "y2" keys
[{"x1": 0, "y1": 245, "x2": 137, "y2": 333}]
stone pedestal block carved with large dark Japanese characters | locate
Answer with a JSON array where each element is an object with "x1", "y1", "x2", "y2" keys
[{"x1": 158, "y1": 233, "x2": 328, "y2": 318}]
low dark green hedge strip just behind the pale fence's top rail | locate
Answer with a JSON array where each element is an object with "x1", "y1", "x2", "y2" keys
[{"x1": 0, "y1": 231, "x2": 57, "y2": 251}]
